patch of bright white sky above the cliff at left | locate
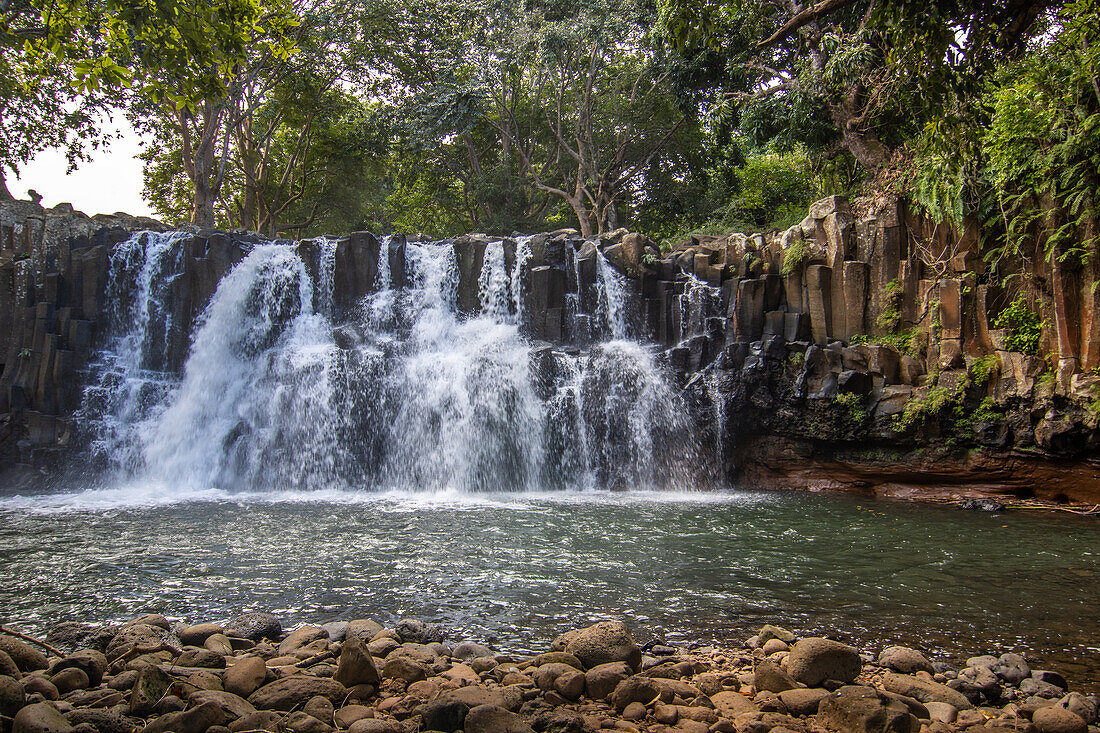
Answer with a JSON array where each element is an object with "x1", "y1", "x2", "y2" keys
[{"x1": 8, "y1": 116, "x2": 153, "y2": 216}]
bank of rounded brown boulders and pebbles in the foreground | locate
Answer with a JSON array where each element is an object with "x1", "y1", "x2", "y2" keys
[{"x1": 0, "y1": 613, "x2": 1100, "y2": 733}]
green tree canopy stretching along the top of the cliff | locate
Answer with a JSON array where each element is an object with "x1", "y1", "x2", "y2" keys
[{"x1": 0, "y1": 0, "x2": 1100, "y2": 259}]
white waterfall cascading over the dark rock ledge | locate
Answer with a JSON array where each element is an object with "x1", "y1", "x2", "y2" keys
[{"x1": 81, "y1": 230, "x2": 699, "y2": 492}]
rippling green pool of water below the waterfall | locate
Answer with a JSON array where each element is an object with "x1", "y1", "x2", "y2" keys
[{"x1": 0, "y1": 486, "x2": 1100, "y2": 691}]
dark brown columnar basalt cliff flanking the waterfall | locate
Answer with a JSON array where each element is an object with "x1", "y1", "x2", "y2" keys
[{"x1": 0, "y1": 197, "x2": 1100, "y2": 502}]
